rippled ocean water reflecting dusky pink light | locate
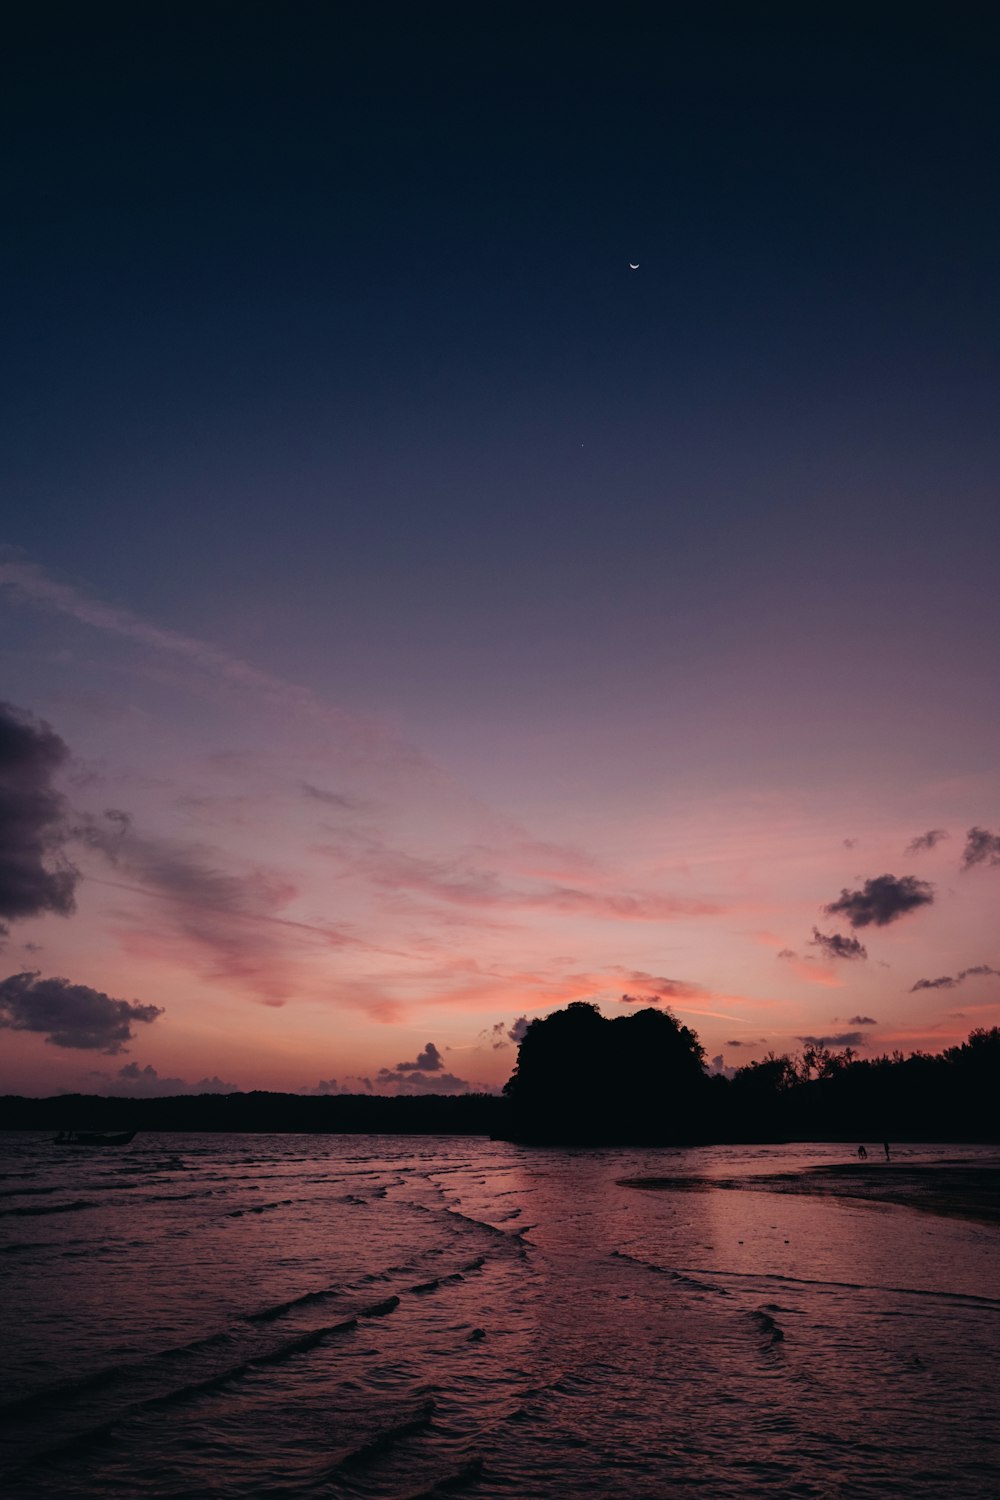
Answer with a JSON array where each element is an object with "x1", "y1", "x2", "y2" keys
[{"x1": 0, "y1": 1134, "x2": 1000, "y2": 1500}]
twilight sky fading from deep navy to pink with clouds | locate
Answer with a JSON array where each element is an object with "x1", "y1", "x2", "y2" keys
[{"x1": 0, "y1": 0, "x2": 1000, "y2": 1094}]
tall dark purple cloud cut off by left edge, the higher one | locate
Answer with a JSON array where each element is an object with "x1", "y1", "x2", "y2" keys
[{"x1": 0, "y1": 704, "x2": 79, "y2": 936}]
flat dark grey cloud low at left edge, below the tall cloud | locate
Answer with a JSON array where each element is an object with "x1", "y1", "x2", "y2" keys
[{"x1": 0, "y1": 971, "x2": 163, "y2": 1055}]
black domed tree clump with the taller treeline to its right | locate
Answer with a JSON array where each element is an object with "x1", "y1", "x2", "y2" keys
[{"x1": 505, "y1": 1001, "x2": 1000, "y2": 1145}]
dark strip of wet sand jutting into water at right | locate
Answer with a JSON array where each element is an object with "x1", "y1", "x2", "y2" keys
[{"x1": 621, "y1": 1157, "x2": 1000, "y2": 1224}]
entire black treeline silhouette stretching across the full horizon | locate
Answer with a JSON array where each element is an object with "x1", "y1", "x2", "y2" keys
[{"x1": 0, "y1": 1001, "x2": 1000, "y2": 1145}]
